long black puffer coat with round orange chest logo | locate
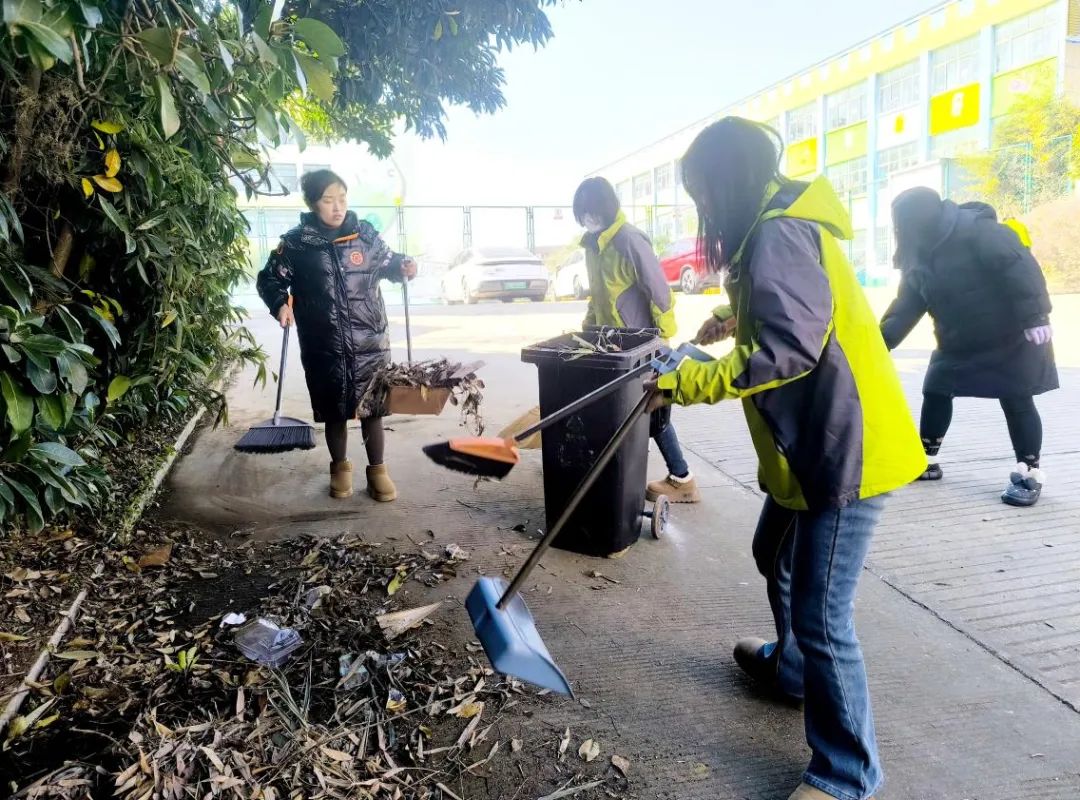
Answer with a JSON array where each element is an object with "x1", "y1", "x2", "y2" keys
[{"x1": 257, "y1": 212, "x2": 403, "y2": 422}]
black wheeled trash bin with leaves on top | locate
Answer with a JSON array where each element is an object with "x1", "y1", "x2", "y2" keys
[{"x1": 522, "y1": 328, "x2": 661, "y2": 556}]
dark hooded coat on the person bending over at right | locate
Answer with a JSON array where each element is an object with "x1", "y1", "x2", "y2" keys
[{"x1": 881, "y1": 201, "x2": 1057, "y2": 397}]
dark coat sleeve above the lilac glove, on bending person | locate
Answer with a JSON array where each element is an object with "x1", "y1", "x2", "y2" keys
[{"x1": 975, "y1": 222, "x2": 1051, "y2": 330}]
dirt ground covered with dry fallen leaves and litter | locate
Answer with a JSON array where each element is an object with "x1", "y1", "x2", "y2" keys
[{"x1": 0, "y1": 524, "x2": 630, "y2": 800}]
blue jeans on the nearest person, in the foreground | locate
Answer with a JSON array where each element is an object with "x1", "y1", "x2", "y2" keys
[{"x1": 754, "y1": 497, "x2": 885, "y2": 800}]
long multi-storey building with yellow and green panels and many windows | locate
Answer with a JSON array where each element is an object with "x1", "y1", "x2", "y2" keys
[{"x1": 594, "y1": 0, "x2": 1080, "y2": 284}]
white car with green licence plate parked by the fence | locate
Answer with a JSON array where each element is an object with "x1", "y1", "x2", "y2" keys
[{"x1": 442, "y1": 247, "x2": 549, "y2": 306}]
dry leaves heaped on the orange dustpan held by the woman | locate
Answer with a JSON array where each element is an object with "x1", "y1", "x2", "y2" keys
[{"x1": 360, "y1": 358, "x2": 484, "y2": 429}]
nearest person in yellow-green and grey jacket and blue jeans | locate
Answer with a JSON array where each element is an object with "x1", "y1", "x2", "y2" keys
[{"x1": 652, "y1": 117, "x2": 926, "y2": 800}]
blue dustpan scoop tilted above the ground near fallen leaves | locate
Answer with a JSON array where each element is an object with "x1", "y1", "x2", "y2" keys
[{"x1": 465, "y1": 578, "x2": 573, "y2": 696}]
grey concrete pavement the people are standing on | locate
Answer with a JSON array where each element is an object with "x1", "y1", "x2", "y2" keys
[{"x1": 165, "y1": 298, "x2": 1080, "y2": 800}]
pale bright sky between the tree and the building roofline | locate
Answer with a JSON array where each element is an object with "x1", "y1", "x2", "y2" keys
[{"x1": 399, "y1": 0, "x2": 935, "y2": 205}]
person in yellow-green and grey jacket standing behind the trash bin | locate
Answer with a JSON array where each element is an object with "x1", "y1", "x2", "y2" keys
[{"x1": 573, "y1": 178, "x2": 701, "y2": 503}]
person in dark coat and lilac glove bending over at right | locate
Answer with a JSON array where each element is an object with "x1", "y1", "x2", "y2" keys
[{"x1": 881, "y1": 187, "x2": 1057, "y2": 506}]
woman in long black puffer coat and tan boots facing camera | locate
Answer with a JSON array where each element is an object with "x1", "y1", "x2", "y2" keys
[{"x1": 257, "y1": 170, "x2": 416, "y2": 502}]
